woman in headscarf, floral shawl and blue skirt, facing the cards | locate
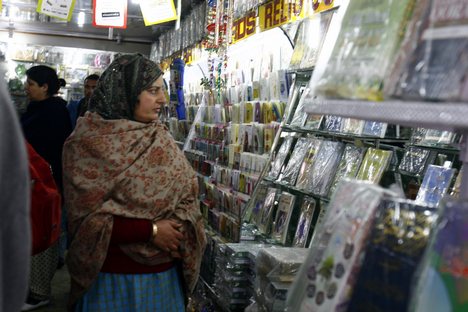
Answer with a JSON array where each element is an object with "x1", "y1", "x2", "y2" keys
[{"x1": 63, "y1": 54, "x2": 205, "y2": 312}]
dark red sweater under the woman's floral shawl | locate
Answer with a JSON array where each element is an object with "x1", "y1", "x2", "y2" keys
[{"x1": 101, "y1": 216, "x2": 173, "y2": 274}]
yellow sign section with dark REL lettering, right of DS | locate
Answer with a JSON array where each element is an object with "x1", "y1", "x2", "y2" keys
[{"x1": 259, "y1": 0, "x2": 305, "y2": 31}]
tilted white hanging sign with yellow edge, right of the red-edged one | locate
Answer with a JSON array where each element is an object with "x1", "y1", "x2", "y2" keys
[{"x1": 140, "y1": 0, "x2": 177, "y2": 26}]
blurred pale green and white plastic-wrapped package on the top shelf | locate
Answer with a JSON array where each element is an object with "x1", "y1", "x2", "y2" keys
[{"x1": 315, "y1": 0, "x2": 415, "y2": 100}]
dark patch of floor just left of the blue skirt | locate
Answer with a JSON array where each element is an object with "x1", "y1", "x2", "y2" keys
[{"x1": 34, "y1": 266, "x2": 70, "y2": 312}]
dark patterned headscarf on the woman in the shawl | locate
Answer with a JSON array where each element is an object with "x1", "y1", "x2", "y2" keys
[{"x1": 89, "y1": 54, "x2": 163, "y2": 120}]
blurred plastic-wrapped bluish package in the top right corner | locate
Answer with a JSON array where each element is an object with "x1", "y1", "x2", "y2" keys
[{"x1": 388, "y1": 0, "x2": 468, "y2": 101}]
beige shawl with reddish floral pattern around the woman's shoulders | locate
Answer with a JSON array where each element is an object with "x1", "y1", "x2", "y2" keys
[{"x1": 63, "y1": 112, "x2": 206, "y2": 304}]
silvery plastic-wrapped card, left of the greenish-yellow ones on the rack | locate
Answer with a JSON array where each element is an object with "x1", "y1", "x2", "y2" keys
[{"x1": 306, "y1": 141, "x2": 344, "y2": 196}]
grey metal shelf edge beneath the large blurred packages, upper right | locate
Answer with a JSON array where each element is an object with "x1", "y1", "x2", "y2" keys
[{"x1": 306, "y1": 99, "x2": 468, "y2": 132}]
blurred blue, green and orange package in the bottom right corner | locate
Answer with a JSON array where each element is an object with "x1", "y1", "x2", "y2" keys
[{"x1": 409, "y1": 199, "x2": 468, "y2": 312}]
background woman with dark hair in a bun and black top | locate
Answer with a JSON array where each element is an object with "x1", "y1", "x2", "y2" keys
[{"x1": 21, "y1": 65, "x2": 72, "y2": 311}]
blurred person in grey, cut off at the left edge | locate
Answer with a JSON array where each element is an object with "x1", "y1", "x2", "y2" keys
[{"x1": 0, "y1": 79, "x2": 31, "y2": 312}]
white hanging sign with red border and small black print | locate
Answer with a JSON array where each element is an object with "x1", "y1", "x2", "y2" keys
[{"x1": 93, "y1": 0, "x2": 127, "y2": 28}]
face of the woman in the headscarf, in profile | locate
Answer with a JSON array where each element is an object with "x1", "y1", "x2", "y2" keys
[{"x1": 134, "y1": 76, "x2": 166, "y2": 123}]
